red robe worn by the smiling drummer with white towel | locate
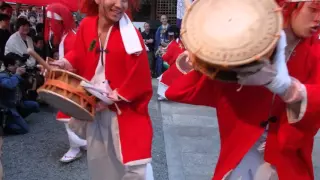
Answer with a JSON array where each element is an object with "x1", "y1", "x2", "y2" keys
[{"x1": 65, "y1": 17, "x2": 153, "y2": 164}]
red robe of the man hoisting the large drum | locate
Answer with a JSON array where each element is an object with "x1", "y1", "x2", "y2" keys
[{"x1": 166, "y1": 38, "x2": 320, "y2": 180}]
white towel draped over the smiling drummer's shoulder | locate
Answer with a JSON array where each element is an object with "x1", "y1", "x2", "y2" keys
[{"x1": 119, "y1": 14, "x2": 142, "y2": 54}]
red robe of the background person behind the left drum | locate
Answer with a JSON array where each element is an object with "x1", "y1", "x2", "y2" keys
[{"x1": 56, "y1": 30, "x2": 76, "y2": 121}]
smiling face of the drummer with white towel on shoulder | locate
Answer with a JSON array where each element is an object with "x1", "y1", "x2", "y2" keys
[{"x1": 95, "y1": 0, "x2": 128, "y2": 22}]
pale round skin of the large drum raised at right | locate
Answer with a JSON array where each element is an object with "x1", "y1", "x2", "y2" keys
[{"x1": 181, "y1": 0, "x2": 283, "y2": 67}]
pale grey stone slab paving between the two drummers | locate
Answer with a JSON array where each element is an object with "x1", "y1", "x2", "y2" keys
[{"x1": 161, "y1": 101, "x2": 320, "y2": 180}]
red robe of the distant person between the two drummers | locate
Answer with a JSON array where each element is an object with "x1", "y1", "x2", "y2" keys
[{"x1": 160, "y1": 40, "x2": 184, "y2": 86}]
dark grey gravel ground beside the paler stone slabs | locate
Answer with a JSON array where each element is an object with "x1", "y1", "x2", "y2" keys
[{"x1": 2, "y1": 84, "x2": 168, "y2": 180}]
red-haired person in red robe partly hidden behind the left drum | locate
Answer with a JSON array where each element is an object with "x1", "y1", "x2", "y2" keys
[{"x1": 45, "y1": 3, "x2": 87, "y2": 163}]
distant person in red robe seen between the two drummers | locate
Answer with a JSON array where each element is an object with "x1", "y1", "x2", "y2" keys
[{"x1": 158, "y1": 38, "x2": 184, "y2": 100}]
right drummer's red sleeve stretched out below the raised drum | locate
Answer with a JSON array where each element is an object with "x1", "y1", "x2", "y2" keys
[{"x1": 166, "y1": 71, "x2": 222, "y2": 107}]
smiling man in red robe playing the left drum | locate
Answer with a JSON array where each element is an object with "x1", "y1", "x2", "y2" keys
[{"x1": 51, "y1": 0, "x2": 153, "y2": 180}]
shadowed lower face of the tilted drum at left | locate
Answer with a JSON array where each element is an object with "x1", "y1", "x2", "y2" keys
[{"x1": 38, "y1": 89, "x2": 93, "y2": 121}]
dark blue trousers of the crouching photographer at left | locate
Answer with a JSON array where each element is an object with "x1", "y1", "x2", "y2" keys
[{"x1": 5, "y1": 101, "x2": 40, "y2": 134}]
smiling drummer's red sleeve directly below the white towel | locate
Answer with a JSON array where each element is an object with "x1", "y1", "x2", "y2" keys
[{"x1": 117, "y1": 33, "x2": 152, "y2": 102}]
